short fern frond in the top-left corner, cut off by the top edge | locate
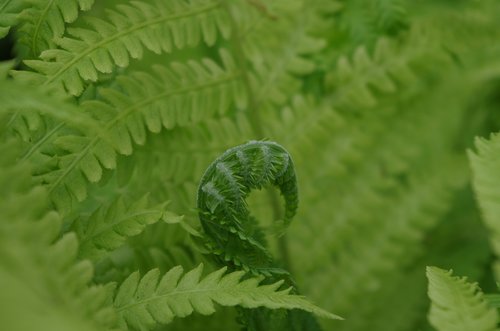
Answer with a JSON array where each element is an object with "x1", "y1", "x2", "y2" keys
[{"x1": 16, "y1": 0, "x2": 94, "y2": 58}]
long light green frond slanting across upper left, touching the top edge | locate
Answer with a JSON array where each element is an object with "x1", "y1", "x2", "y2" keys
[{"x1": 17, "y1": 0, "x2": 230, "y2": 96}]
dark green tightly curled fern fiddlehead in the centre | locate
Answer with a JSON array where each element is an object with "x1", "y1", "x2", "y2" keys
[{"x1": 197, "y1": 141, "x2": 298, "y2": 274}]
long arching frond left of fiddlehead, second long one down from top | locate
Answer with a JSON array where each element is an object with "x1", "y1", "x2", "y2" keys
[{"x1": 28, "y1": 51, "x2": 246, "y2": 213}]
